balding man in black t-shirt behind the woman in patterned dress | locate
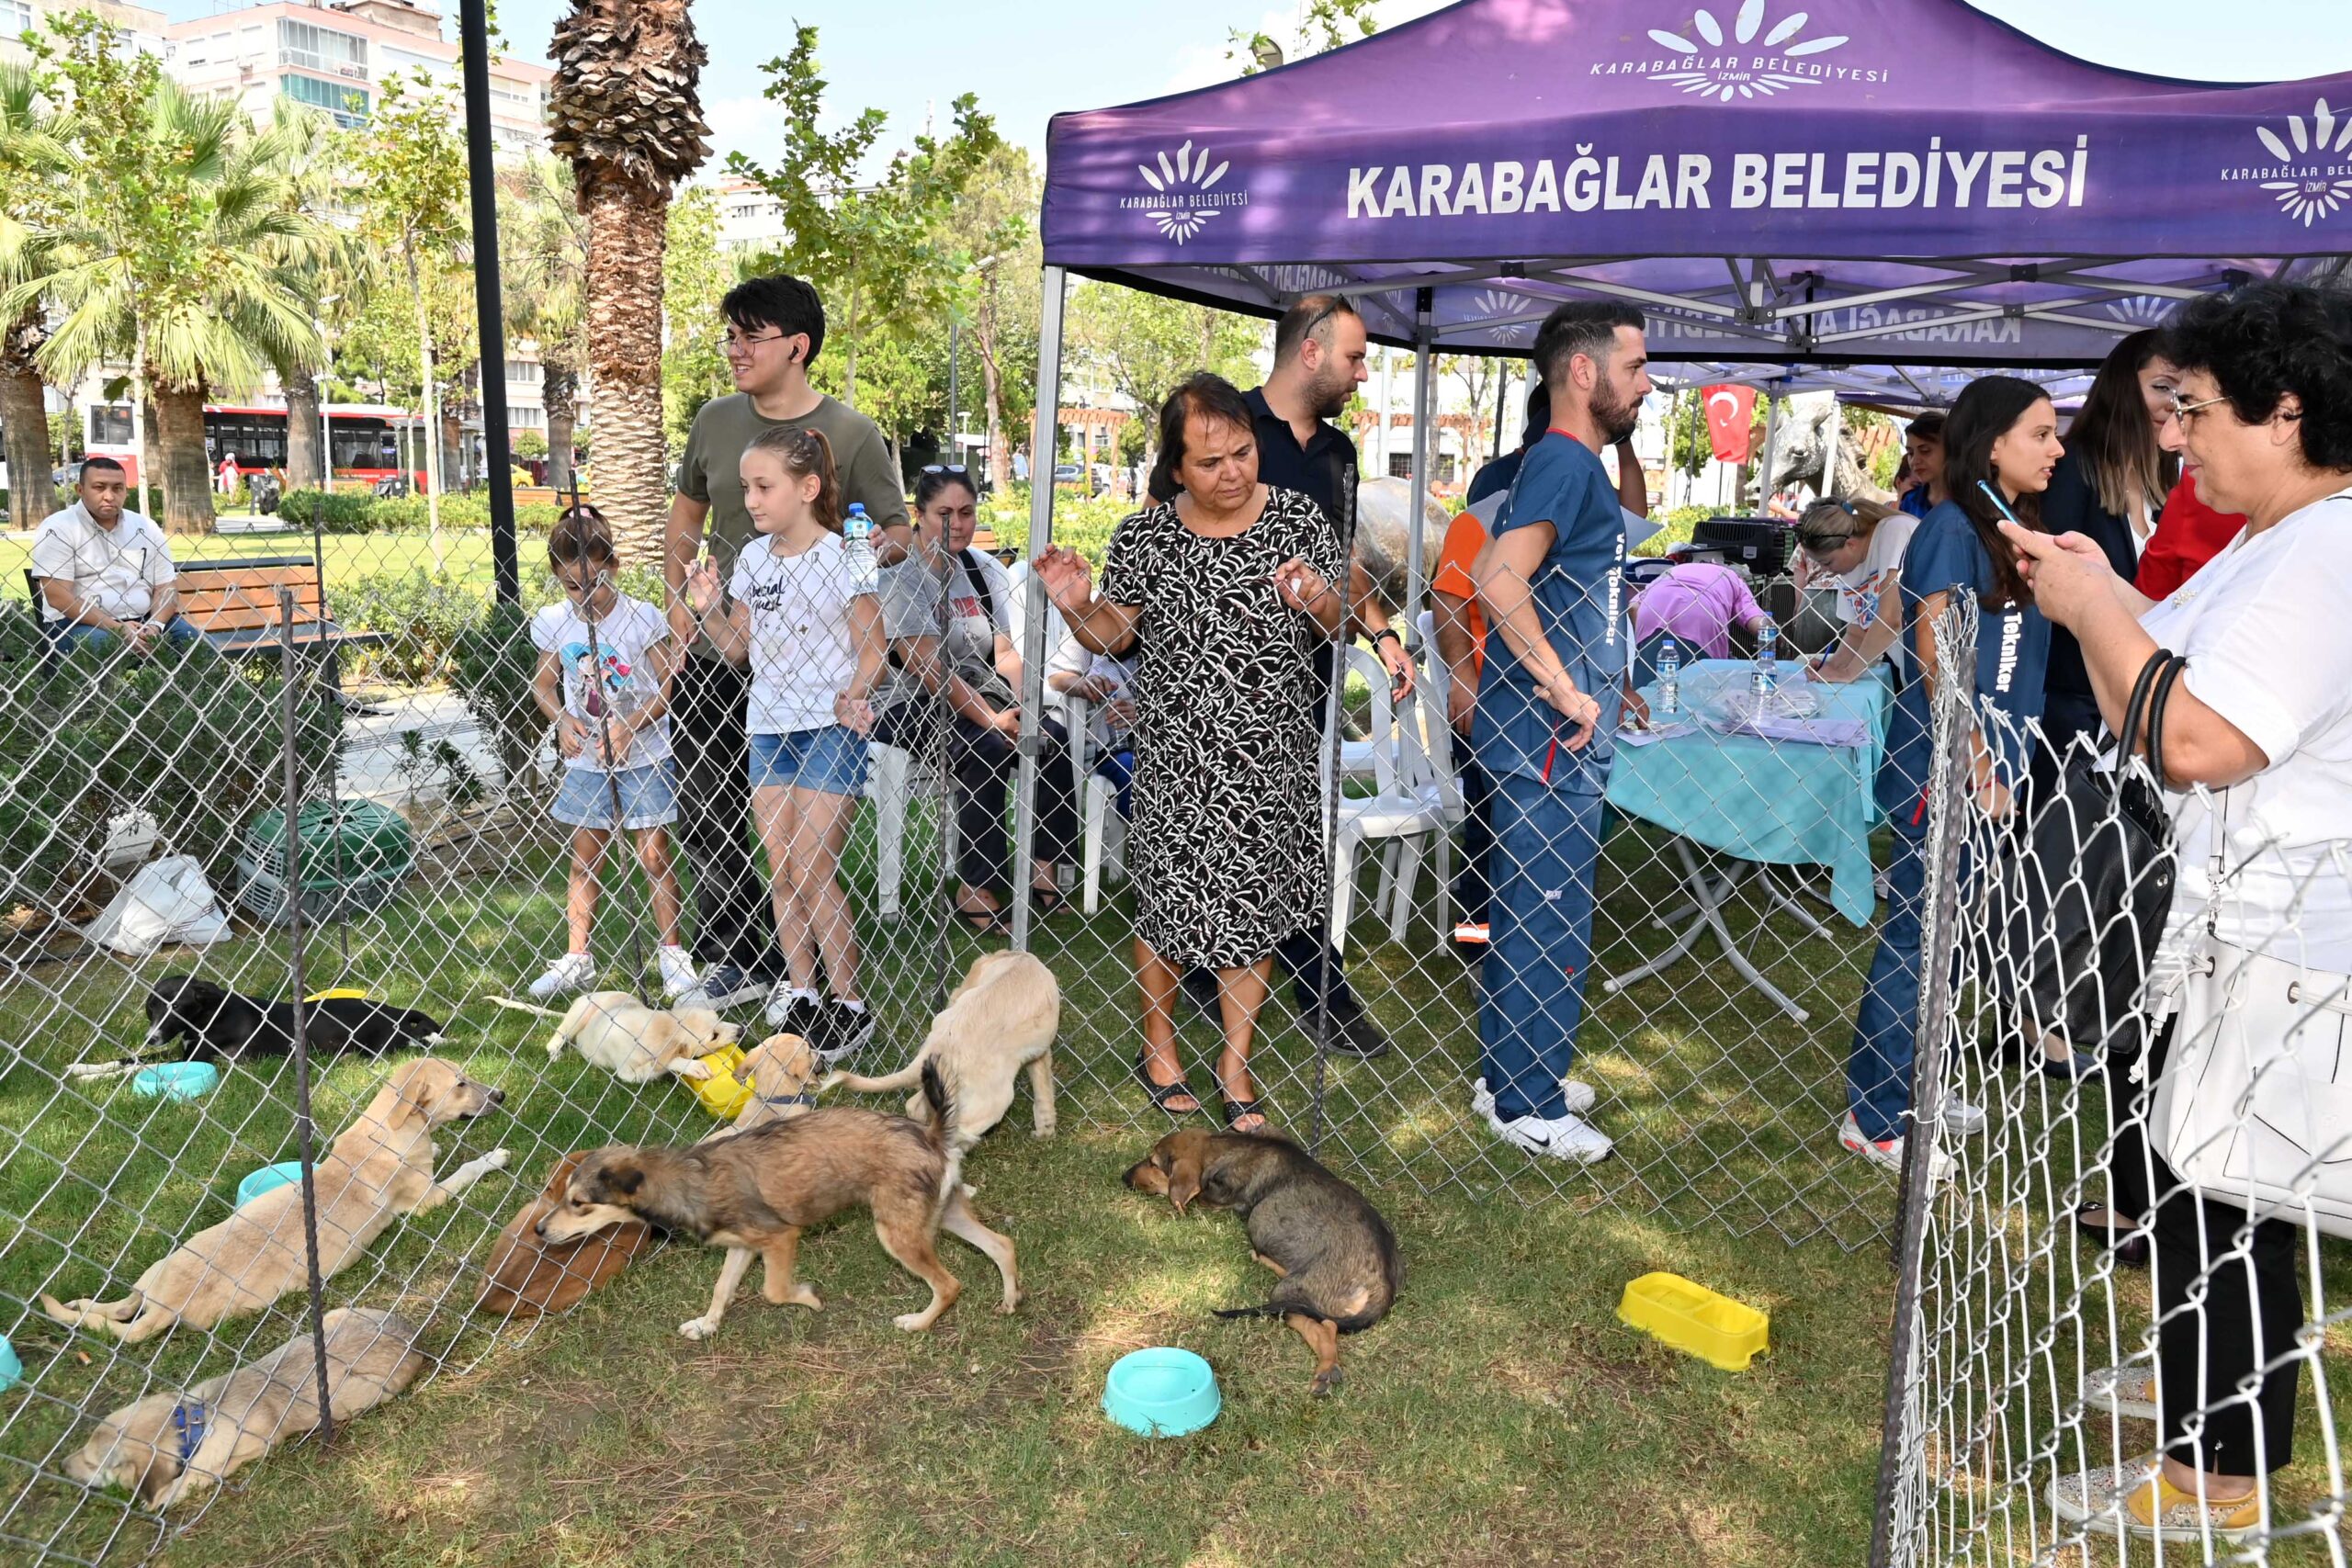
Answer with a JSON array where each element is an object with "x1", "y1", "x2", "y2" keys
[{"x1": 1152, "y1": 294, "x2": 1419, "y2": 1055}]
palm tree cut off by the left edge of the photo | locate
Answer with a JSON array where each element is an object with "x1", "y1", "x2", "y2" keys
[{"x1": 0, "y1": 63, "x2": 71, "y2": 529}]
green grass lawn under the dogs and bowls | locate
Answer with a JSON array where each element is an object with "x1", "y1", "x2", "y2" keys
[{"x1": 0, "y1": 811, "x2": 2352, "y2": 1568}]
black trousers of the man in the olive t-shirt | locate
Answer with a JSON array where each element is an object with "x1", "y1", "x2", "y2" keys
[{"x1": 671, "y1": 656, "x2": 776, "y2": 971}]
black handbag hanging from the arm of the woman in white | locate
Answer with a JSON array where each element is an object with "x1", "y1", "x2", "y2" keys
[{"x1": 1992, "y1": 649, "x2": 2189, "y2": 1054}]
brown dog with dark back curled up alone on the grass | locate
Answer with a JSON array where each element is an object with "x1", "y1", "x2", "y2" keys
[{"x1": 1125, "y1": 1128, "x2": 1404, "y2": 1394}]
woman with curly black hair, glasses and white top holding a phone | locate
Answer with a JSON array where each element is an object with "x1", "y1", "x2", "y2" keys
[{"x1": 2013, "y1": 282, "x2": 2352, "y2": 1556}]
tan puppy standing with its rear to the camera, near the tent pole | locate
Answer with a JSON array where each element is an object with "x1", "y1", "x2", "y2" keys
[{"x1": 819, "y1": 952, "x2": 1061, "y2": 1149}]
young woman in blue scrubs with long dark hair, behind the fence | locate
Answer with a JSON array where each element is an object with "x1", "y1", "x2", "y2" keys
[{"x1": 1839, "y1": 376, "x2": 2065, "y2": 1173}]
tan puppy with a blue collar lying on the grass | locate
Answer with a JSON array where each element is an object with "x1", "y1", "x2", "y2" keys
[{"x1": 66, "y1": 1307, "x2": 425, "y2": 1509}]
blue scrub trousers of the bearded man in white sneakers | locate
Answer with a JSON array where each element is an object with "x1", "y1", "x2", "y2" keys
[{"x1": 1477, "y1": 773, "x2": 1601, "y2": 1122}]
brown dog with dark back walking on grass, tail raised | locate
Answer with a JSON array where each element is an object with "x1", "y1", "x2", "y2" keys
[{"x1": 538, "y1": 1063, "x2": 1021, "y2": 1340}]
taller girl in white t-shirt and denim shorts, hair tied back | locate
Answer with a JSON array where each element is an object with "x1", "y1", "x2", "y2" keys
[{"x1": 673, "y1": 428, "x2": 885, "y2": 1063}]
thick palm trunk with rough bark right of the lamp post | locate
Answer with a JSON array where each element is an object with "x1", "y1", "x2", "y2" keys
[{"x1": 548, "y1": 0, "x2": 710, "y2": 562}]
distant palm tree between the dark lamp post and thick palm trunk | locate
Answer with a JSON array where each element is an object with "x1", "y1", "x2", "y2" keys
[{"x1": 499, "y1": 157, "x2": 588, "y2": 489}]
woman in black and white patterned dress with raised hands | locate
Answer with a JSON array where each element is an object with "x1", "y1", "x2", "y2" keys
[{"x1": 1037, "y1": 374, "x2": 1343, "y2": 1131}]
